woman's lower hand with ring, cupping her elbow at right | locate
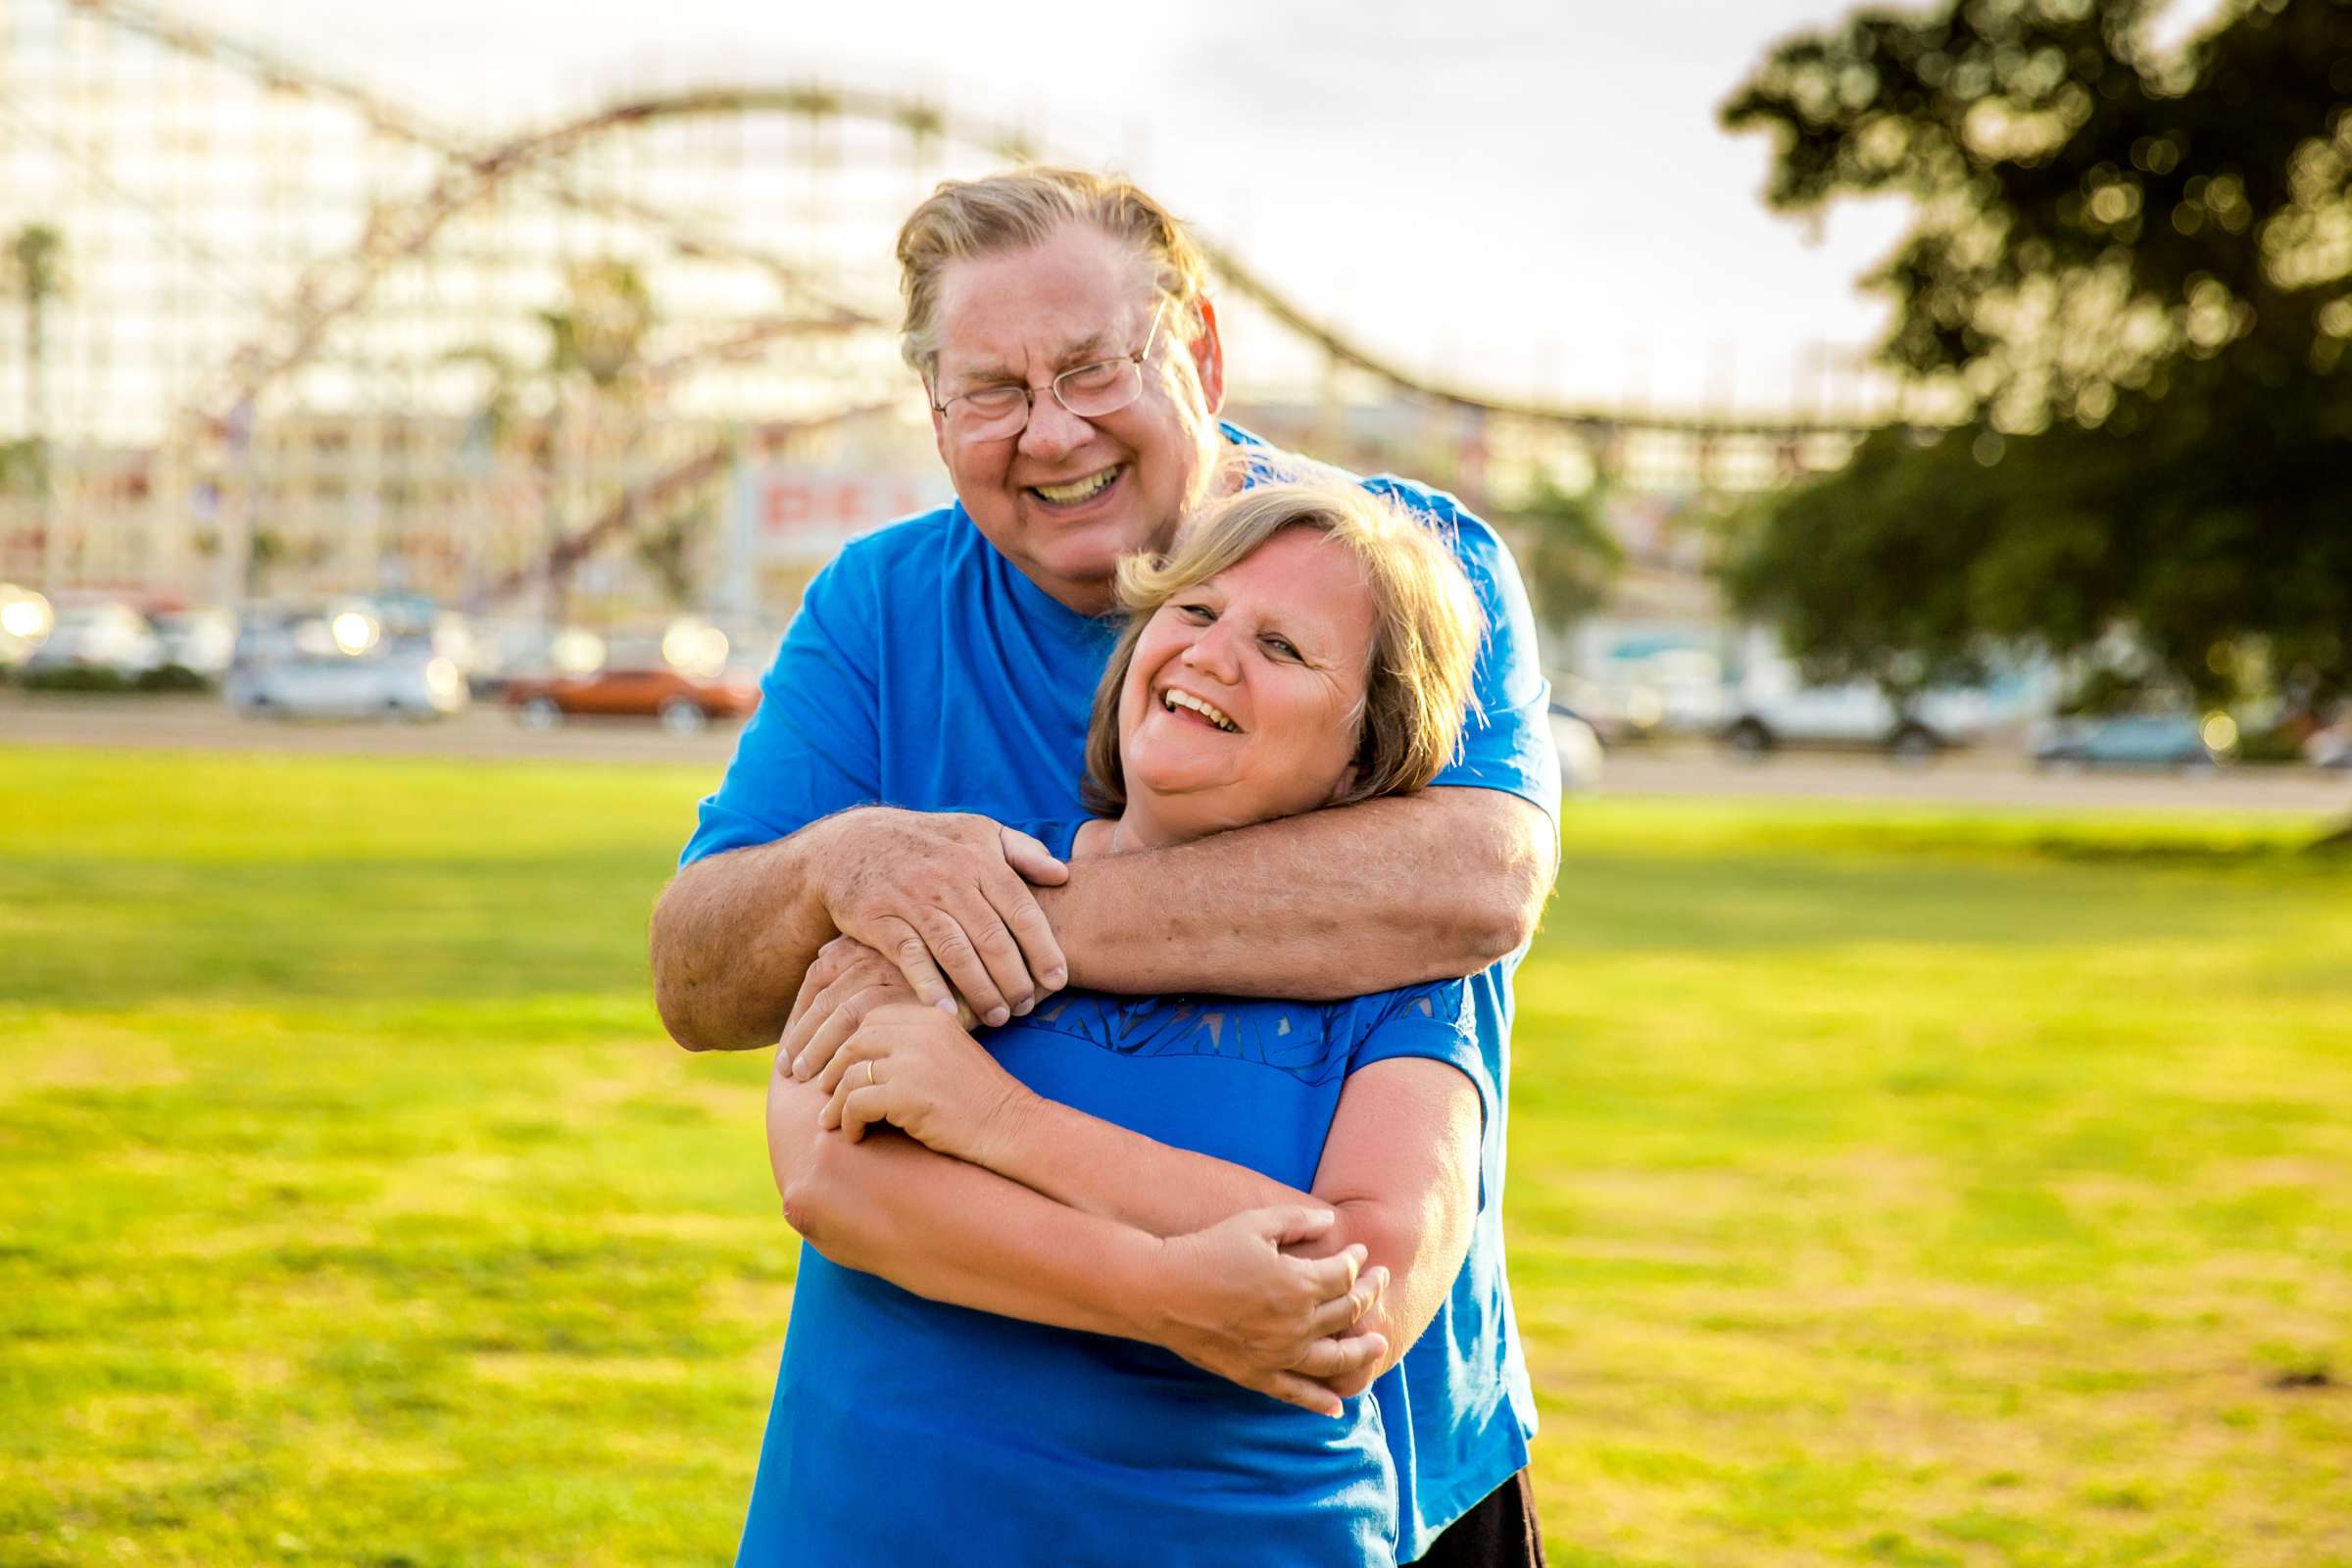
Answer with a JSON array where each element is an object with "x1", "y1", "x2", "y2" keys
[{"x1": 1152, "y1": 1206, "x2": 1388, "y2": 1415}]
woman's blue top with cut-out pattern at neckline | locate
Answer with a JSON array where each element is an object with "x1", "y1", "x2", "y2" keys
[{"x1": 736, "y1": 980, "x2": 1495, "y2": 1568}]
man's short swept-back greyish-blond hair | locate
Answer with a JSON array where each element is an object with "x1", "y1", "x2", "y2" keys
[{"x1": 899, "y1": 165, "x2": 1209, "y2": 381}]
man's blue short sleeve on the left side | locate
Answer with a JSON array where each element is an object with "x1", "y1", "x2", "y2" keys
[{"x1": 677, "y1": 546, "x2": 882, "y2": 865}]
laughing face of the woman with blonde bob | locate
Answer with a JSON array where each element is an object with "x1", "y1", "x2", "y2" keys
[{"x1": 1119, "y1": 526, "x2": 1374, "y2": 844}]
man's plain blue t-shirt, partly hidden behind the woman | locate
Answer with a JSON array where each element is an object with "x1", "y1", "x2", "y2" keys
[{"x1": 682, "y1": 425, "x2": 1559, "y2": 1561}]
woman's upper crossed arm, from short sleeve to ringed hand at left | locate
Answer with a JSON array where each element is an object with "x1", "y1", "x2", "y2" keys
[{"x1": 811, "y1": 1006, "x2": 1480, "y2": 1392}]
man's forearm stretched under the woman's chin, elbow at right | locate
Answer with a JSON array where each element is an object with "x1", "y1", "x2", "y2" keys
[{"x1": 1037, "y1": 790, "x2": 1559, "y2": 1002}]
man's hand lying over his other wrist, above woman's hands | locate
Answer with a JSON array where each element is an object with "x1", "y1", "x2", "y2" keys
[{"x1": 802, "y1": 807, "x2": 1070, "y2": 1025}]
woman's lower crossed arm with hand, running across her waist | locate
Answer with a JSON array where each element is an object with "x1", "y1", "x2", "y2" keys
[{"x1": 769, "y1": 1067, "x2": 1388, "y2": 1415}]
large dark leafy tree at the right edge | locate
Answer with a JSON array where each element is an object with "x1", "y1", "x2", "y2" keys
[{"x1": 1724, "y1": 0, "x2": 2352, "y2": 703}]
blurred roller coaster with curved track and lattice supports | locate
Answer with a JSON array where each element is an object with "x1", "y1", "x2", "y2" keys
[{"x1": 0, "y1": 0, "x2": 1851, "y2": 618}]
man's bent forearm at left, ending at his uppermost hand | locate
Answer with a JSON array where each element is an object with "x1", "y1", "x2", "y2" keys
[{"x1": 649, "y1": 825, "x2": 835, "y2": 1051}]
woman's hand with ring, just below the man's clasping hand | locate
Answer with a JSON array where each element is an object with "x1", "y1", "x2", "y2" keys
[{"x1": 816, "y1": 1004, "x2": 1035, "y2": 1168}]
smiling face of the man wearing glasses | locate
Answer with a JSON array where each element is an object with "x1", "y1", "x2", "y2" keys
[{"x1": 931, "y1": 223, "x2": 1225, "y2": 615}]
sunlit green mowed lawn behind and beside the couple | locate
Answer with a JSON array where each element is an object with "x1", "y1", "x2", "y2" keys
[{"x1": 0, "y1": 748, "x2": 2352, "y2": 1568}]
